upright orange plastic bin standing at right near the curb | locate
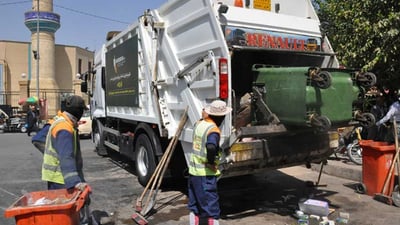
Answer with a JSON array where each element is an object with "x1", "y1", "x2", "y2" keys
[{"x1": 360, "y1": 140, "x2": 396, "y2": 196}]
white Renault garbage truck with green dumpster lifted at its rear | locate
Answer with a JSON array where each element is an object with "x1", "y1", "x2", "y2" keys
[{"x1": 81, "y1": 0, "x2": 376, "y2": 185}]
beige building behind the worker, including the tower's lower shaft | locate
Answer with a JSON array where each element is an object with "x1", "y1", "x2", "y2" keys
[{"x1": 0, "y1": 40, "x2": 94, "y2": 117}]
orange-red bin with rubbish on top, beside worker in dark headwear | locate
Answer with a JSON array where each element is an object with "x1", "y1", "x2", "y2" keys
[{"x1": 4, "y1": 187, "x2": 90, "y2": 225}]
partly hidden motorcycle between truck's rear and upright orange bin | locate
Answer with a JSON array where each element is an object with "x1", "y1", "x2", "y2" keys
[{"x1": 334, "y1": 125, "x2": 363, "y2": 165}]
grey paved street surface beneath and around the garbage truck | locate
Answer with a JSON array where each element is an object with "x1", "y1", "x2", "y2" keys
[{"x1": 0, "y1": 133, "x2": 400, "y2": 225}]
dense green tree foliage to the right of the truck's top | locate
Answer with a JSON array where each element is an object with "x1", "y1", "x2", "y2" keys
[{"x1": 314, "y1": 0, "x2": 400, "y2": 87}]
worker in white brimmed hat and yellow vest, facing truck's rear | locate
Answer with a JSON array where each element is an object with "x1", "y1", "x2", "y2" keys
[{"x1": 188, "y1": 100, "x2": 232, "y2": 225}]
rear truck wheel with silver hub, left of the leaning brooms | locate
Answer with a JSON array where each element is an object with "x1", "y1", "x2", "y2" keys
[{"x1": 135, "y1": 133, "x2": 156, "y2": 186}]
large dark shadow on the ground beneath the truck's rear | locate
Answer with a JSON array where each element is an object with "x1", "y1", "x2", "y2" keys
[{"x1": 219, "y1": 170, "x2": 336, "y2": 220}]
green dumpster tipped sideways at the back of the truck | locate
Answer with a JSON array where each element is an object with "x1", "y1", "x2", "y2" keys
[{"x1": 253, "y1": 67, "x2": 360, "y2": 126}]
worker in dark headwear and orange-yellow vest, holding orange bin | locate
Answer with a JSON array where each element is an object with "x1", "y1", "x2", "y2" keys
[{"x1": 42, "y1": 95, "x2": 90, "y2": 224}]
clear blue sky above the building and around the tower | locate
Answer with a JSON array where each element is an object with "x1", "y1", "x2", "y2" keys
[{"x1": 0, "y1": 0, "x2": 167, "y2": 51}]
